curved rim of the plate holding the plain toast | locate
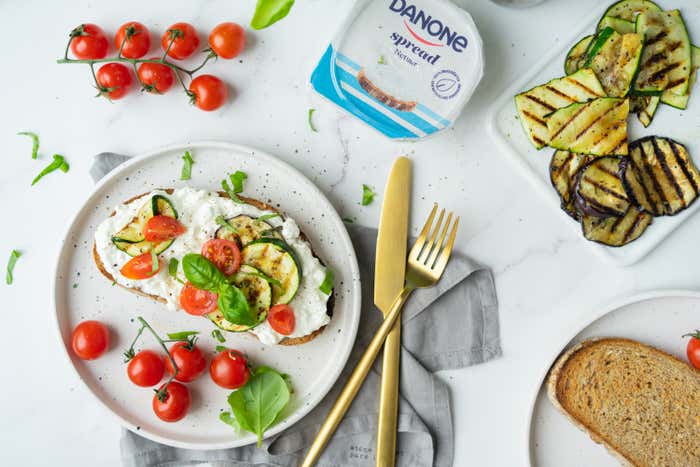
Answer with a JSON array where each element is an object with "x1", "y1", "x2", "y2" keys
[{"x1": 524, "y1": 289, "x2": 700, "y2": 467}]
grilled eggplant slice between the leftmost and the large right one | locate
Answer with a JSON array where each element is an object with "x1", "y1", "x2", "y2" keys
[{"x1": 576, "y1": 157, "x2": 630, "y2": 217}]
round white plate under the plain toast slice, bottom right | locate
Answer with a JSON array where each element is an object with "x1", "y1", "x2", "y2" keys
[{"x1": 528, "y1": 291, "x2": 700, "y2": 467}]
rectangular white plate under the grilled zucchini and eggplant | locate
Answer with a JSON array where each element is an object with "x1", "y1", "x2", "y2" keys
[{"x1": 490, "y1": 0, "x2": 700, "y2": 265}]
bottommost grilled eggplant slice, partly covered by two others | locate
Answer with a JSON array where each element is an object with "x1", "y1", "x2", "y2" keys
[{"x1": 581, "y1": 206, "x2": 654, "y2": 247}]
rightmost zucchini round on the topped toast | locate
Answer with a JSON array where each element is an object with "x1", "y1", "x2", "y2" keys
[{"x1": 241, "y1": 238, "x2": 301, "y2": 305}]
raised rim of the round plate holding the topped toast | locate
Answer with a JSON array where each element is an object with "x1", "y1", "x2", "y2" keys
[{"x1": 50, "y1": 141, "x2": 362, "y2": 450}]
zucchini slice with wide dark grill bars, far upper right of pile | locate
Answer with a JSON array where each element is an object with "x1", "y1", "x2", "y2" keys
[{"x1": 634, "y1": 10, "x2": 692, "y2": 96}]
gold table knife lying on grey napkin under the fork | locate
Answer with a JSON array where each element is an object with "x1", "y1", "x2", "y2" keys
[{"x1": 374, "y1": 157, "x2": 411, "y2": 467}]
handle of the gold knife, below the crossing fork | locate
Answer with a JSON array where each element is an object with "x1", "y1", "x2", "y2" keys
[{"x1": 377, "y1": 320, "x2": 401, "y2": 467}]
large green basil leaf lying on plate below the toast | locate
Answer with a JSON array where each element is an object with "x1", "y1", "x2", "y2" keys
[{"x1": 228, "y1": 369, "x2": 291, "y2": 447}]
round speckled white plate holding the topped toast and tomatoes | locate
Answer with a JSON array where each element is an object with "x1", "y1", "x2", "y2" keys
[{"x1": 53, "y1": 143, "x2": 361, "y2": 449}]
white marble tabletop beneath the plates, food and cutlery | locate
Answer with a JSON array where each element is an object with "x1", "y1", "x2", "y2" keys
[{"x1": 0, "y1": 0, "x2": 700, "y2": 466}]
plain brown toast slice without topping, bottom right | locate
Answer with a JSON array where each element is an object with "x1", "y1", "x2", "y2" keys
[{"x1": 547, "y1": 338, "x2": 700, "y2": 466}]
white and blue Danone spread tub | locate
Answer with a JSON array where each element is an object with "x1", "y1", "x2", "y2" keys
[{"x1": 311, "y1": 0, "x2": 484, "y2": 139}]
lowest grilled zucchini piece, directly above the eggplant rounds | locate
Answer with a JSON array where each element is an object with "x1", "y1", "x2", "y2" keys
[{"x1": 547, "y1": 98, "x2": 629, "y2": 156}]
